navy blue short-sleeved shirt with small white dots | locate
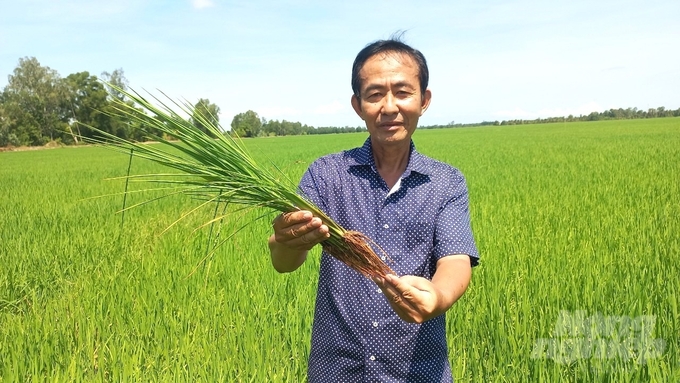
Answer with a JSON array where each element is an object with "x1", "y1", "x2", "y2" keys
[{"x1": 300, "y1": 138, "x2": 479, "y2": 383}]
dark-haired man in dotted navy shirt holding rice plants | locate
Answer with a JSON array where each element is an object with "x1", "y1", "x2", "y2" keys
[{"x1": 269, "y1": 39, "x2": 479, "y2": 382}]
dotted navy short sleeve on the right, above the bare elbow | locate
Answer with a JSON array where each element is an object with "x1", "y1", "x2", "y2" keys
[{"x1": 434, "y1": 170, "x2": 479, "y2": 266}]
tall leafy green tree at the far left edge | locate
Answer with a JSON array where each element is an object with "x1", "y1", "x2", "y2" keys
[{"x1": 2, "y1": 57, "x2": 67, "y2": 145}]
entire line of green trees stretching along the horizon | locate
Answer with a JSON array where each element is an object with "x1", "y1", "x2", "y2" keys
[{"x1": 0, "y1": 57, "x2": 680, "y2": 147}]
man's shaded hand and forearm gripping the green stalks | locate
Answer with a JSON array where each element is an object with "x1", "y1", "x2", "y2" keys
[{"x1": 269, "y1": 210, "x2": 330, "y2": 273}]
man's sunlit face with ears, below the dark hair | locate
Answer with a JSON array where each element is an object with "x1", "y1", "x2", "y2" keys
[{"x1": 352, "y1": 53, "x2": 431, "y2": 147}]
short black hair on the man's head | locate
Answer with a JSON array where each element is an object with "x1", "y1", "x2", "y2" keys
[{"x1": 352, "y1": 33, "x2": 430, "y2": 98}]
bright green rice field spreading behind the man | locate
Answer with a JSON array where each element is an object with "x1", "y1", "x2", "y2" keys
[{"x1": 0, "y1": 118, "x2": 680, "y2": 383}]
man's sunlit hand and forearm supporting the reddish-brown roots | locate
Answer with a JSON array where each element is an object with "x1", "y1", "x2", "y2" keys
[{"x1": 375, "y1": 255, "x2": 472, "y2": 323}]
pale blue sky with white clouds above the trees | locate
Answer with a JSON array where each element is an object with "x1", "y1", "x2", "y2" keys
[{"x1": 0, "y1": 0, "x2": 680, "y2": 127}]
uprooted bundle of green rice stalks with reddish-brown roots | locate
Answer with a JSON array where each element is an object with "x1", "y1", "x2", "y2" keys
[{"x1": 96, "y1": 85, "x2": 394, "y2": 278}]
